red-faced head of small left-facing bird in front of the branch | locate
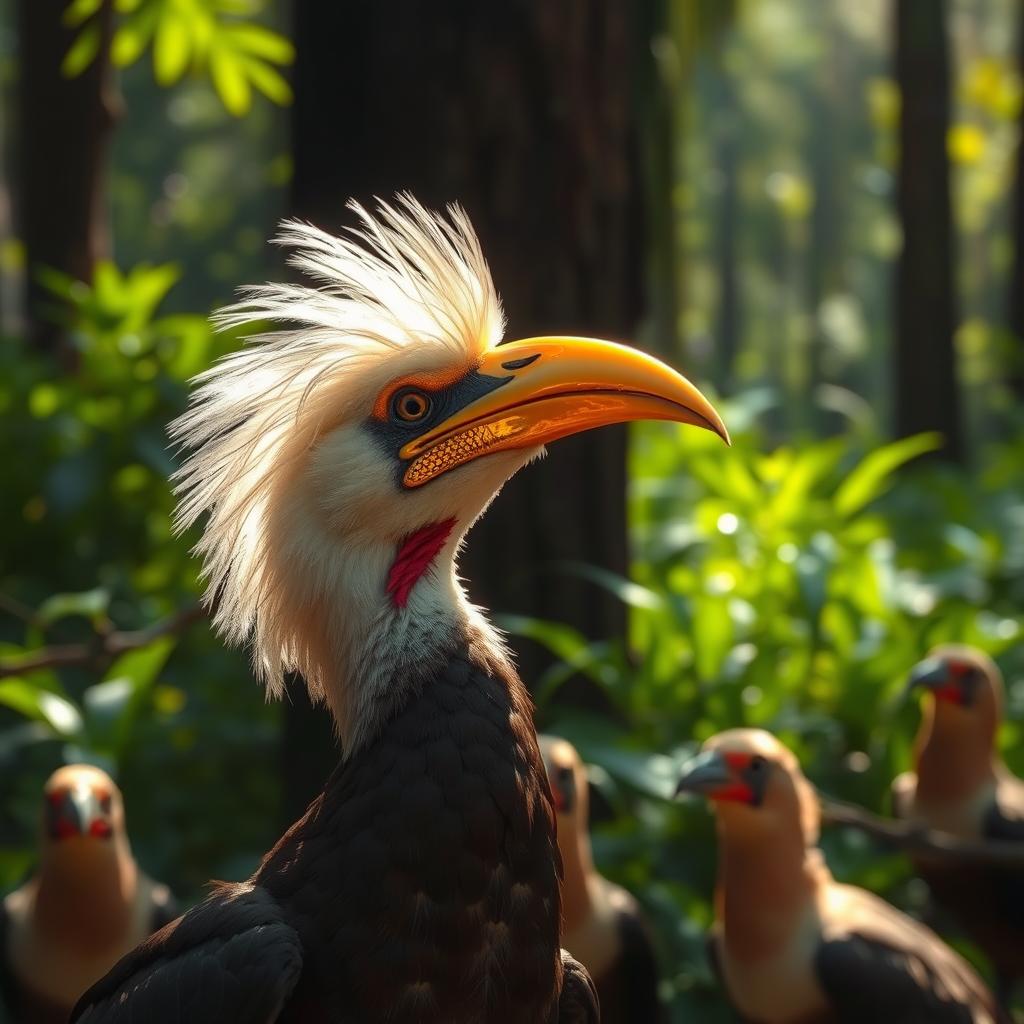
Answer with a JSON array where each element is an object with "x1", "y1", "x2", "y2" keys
[{"x1": 676, "y1": 729, "x2": 820, "y2": 846}]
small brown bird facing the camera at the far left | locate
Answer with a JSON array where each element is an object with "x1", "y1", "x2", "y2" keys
[{"x1": 0, "y1": 764, "x2": 178, "y2": 1024}]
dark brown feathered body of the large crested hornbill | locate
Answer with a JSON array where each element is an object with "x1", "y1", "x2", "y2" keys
[{"x1": 77, "y1": 652, "x2": 569, "y2": 1024}]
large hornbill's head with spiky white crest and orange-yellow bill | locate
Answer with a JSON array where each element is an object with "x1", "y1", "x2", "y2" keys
[{"x1": 171, "y1": 197, "x2": 727, "y2": 738}]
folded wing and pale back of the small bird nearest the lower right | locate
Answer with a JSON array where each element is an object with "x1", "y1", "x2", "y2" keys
[{"x1": 814, "y1": 886, "x2": 1000, "y2": 1024}]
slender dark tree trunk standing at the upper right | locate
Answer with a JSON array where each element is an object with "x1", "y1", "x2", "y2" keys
[{"x1": 894, "y1": 0, "x2": 965, "y2": 461}]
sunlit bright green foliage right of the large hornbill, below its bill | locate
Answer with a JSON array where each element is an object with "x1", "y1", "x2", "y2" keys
[{"x1": 505, "y1": 403, "x2": 1024, "y2": 1021}]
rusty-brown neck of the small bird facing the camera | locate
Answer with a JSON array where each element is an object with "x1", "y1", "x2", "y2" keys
[{"x1": 33, "y1": 840, "x2": 138, "y2": 949}]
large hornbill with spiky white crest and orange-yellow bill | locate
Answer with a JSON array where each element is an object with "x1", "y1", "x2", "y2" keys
[{"x1": 75, "y1": 194, "x2": 728, "y2": 1024}]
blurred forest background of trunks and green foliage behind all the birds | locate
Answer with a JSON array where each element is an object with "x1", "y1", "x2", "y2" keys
[{"x1": 0, "y1": 0, "x2": 1024, "y2": 1022}]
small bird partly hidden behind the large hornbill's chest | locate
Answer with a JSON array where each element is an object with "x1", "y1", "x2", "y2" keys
[{"x1": 539, "y1": 734, "x2": 664, "y2": 1024}]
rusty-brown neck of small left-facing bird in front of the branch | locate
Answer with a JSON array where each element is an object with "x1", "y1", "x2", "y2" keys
[{"x1": 715, "y1": 829, "x2": 831, "y2": 963}]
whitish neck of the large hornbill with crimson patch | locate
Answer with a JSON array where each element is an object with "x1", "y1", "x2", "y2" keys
[{"x1": 296, "y1": 522, "x2": 516, "y2": 757}]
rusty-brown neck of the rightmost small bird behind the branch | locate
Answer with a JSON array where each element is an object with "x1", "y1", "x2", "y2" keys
[{"x1": 916, "y1": 710, "x2": 1000, "y2": 803}]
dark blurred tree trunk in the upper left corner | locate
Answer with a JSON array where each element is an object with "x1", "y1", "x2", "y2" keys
[{"x1": 14, "y1": 0, "x2": 119, "y2": 358}]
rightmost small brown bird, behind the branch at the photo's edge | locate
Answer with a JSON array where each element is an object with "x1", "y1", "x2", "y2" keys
[{"x1": 892, "y1": 644, "x2": 1024, "y2": 1002}]
